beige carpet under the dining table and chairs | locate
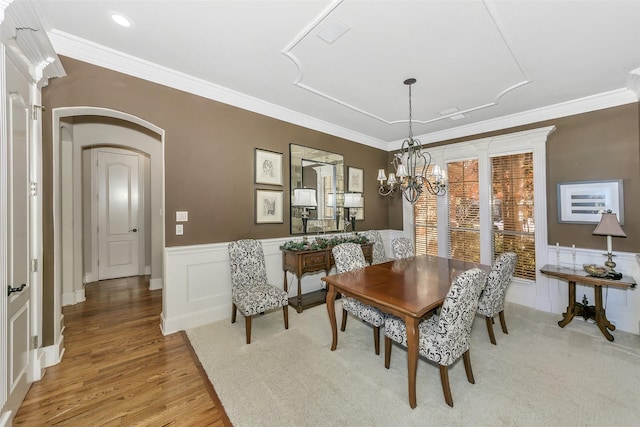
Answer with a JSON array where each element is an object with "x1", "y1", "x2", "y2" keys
[{"x1": 187, "y1": 301, "x2": 640, "y2": 427}]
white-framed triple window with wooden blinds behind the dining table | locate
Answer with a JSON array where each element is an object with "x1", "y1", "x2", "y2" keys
[{"x1": 404, "y1": 126, "x2": 554, "y2": 282}]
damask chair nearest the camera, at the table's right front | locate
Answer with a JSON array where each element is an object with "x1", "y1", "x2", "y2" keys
[{"x1": 384, "y1": 268, "x2": 487, "y2": 406}]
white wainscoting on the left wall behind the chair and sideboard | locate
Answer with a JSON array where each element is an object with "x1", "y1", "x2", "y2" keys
[{"x1": 161, "y1": 230, "x2": 402, "y2": 335}]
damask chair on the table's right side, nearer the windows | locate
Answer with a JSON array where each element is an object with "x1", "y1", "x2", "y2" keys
[{"x1": 478, "y1": 252, "x2": 518, "y2": 345}]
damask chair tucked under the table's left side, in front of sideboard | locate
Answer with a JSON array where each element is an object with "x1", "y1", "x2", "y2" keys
[{"x1": 331, "y1": 243, "x2": 386, "y2": 354}]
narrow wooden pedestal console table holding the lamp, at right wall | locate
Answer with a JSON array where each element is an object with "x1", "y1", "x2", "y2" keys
[{"x1": 540, "y1": 265, "x2": 636, "y2": 341}]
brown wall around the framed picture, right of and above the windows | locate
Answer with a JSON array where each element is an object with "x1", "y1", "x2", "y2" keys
[{"x1": 389, "y1": 103, "x2": 640, "y2": 252}]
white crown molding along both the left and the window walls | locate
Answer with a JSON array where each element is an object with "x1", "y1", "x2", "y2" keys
[{"x1": 48, "y1": 30, "x2": 640, "y2": 155}]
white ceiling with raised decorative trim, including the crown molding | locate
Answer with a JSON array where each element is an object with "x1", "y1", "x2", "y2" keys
[{"x1": 26, "y1": 0, "x2": 640, "y2": 149}]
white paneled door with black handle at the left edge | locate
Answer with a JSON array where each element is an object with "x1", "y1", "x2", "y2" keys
[{"x1": 2, "y1": 58, "x2": 35, "y2": 420}]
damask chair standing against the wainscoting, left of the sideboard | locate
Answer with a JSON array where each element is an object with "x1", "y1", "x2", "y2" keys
[{"x1": 229, "y1": 239, "x2": 289, "y2": 344}]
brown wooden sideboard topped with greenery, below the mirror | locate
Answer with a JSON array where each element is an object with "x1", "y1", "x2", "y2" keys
[{"x1": 282, "y1": 243, "x2": 373, "y2": 313}]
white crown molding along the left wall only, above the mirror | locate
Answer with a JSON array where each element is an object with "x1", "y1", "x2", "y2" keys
[{"x1": 47, "y1": 29, "x2": 388, "y2": 150}]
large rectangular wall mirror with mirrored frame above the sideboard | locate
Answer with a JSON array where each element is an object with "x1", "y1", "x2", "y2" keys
[{"x1": 289, "y1": 143, "x2": 345, "y2": 235}]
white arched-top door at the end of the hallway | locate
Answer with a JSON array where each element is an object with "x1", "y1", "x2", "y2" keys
[{"x1": 98, "y1": 150, "x2": 140, "y2": 280}]
